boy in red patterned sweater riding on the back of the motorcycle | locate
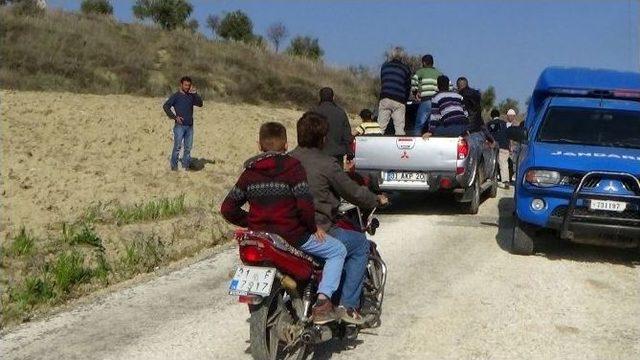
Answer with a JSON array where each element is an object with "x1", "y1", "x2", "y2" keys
[{"x1": 221, "y1": 122, "x2": 347, "y2": 324}]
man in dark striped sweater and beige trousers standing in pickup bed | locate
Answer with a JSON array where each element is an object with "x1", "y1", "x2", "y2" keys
[{"x1": 378, "y1": 47, "x2": 411, "y2": 135}]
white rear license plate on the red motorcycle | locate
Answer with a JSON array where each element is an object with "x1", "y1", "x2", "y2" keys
[{"x1": 229, "y1": 265, "x2": 276, "y2": 296}]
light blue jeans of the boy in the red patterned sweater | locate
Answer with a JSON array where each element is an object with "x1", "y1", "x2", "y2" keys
[{"x1": 300, "y1": 235, "x2": 347, "y2": 298}]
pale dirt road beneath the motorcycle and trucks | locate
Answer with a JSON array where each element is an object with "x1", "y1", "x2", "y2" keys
[{"x1": 2, "y1": 193, "x2": 640, "y2": 359}]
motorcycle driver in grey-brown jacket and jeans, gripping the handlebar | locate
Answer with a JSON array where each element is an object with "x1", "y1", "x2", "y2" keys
[{"x1": 290, "y1": 112, "x2": 388, "y2": 324}]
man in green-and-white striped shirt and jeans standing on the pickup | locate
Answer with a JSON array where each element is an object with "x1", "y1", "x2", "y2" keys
[{"x1": 411, "y1": 54, "x2": 442, "y2": 136}]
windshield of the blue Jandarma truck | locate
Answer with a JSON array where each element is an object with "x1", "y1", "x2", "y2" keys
[{"x1": 537, "y1": 108, "x2": 640, "y2": 148}]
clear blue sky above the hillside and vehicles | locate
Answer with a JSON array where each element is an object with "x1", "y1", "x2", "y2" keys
[{"x1": 48, "y1": 0, "x2": 640, "y2": 107}]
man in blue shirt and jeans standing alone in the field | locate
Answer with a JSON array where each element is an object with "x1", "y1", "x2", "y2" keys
[{"x1": 162, "y1": 76, "x2": 202, "y2": 171}]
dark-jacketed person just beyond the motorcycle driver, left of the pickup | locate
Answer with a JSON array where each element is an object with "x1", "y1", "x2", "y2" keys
[{"x1": 313, "y1": 87, "x2": 353, "y2": 164}]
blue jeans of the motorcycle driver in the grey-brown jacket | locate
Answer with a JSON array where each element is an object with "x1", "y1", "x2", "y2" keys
[{"x1": 329, "y1": 228, "x2": 370, "y2": 309}]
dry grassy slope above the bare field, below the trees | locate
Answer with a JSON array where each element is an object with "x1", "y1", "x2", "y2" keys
[{"x1": 0, "y1": 9, "x2": 375, "y2": 112}]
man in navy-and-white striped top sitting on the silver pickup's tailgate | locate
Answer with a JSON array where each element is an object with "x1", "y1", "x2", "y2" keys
[{"x1": 422, "y1": 75, "x2": 469, "y2": 139}]
